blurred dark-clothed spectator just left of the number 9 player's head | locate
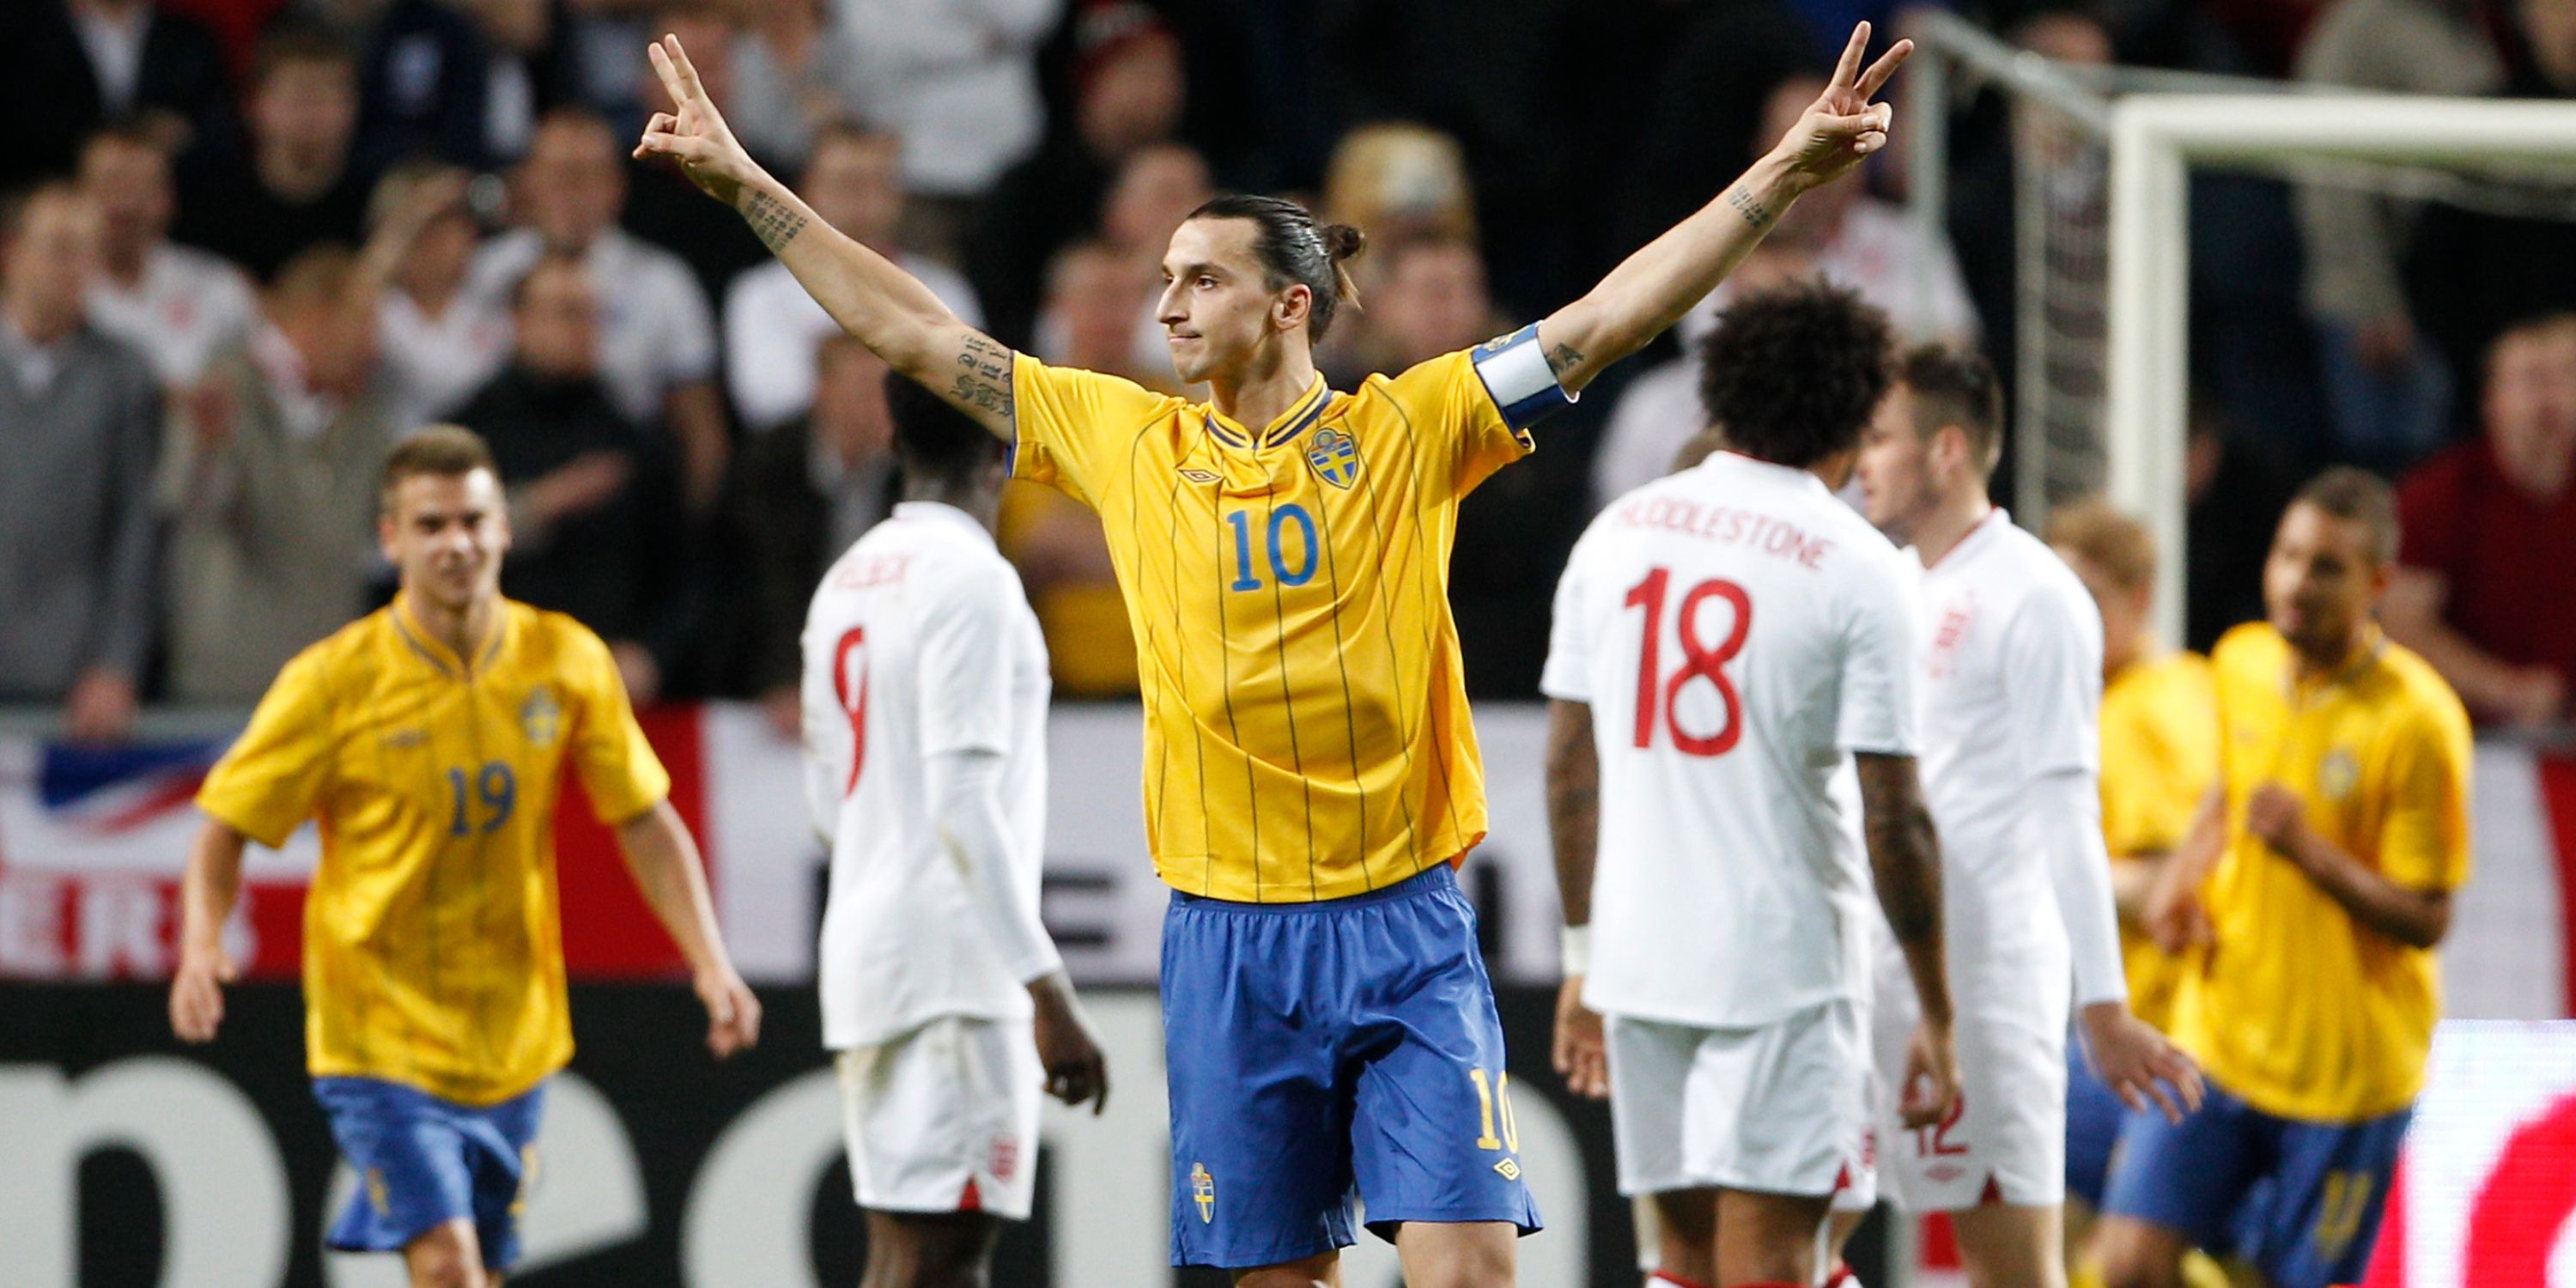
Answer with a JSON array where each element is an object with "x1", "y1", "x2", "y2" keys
[{"x1": 729, "y1": 332, "x2": 902, "y2": 737}]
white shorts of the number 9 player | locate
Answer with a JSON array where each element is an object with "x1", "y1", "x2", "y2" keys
[{"x1": 835, "y1": 1015, "x2": 1046, "y2": 1221}]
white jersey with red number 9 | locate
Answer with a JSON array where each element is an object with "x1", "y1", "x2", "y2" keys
[{"x1": 804, "y1": 502, "x2": 1048, "y2": 1048}]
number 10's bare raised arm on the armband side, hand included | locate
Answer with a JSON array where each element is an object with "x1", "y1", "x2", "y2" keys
[{"x1": 1538, "y1": 23, "x2": 1914, "y2": 394}]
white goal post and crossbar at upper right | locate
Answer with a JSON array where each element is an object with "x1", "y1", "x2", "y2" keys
[{"x1": 2105, "y1": 93, "x2": 2576, "y2": 639}]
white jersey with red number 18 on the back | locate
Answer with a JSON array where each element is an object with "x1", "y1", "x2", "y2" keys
[{"x1": 1540, "y1": 453, "x2": 1919, "y2": 1028}]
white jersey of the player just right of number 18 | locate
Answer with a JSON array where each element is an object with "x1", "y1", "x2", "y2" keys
[{"x1": 1922, "y1": 510, "x2": 2102, "y2": 1010}]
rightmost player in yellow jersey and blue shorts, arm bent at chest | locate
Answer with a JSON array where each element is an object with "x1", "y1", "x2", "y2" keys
[{"x1": 2102, "y1": 469, "x2": 2470, "y2": 1288}]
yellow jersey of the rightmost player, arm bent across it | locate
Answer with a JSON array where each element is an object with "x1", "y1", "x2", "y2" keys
[{"x1": 2174, "y1": 623, "x2": 2470, "y2": 1123}]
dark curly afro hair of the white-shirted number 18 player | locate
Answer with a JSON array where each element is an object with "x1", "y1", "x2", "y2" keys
[{"x1": 1700, "y1": 283, "x2": 1893, "y2": 469}]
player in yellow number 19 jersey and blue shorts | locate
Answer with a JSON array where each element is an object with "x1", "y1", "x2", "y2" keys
[{"x1": 170, "y1": 425, "x2": 760, "y2": 1285}]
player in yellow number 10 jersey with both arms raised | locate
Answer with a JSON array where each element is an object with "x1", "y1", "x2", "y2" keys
[{"x1": 636, "y1": 23, "x2": 1909, "y2": 1288}]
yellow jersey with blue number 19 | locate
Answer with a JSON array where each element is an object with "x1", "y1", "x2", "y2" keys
[{"x1": 196, "y1": 598, "x2": 670, "y2": 1105}]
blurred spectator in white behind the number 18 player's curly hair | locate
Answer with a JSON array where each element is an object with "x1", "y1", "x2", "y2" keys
[{"x1": 1592, "y1": 72, "x2": 1978, "y2": 510}]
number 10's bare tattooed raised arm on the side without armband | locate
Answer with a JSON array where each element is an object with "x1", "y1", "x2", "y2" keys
[{"x1": 634, "y1": 36, "x2": 1012, "y2": 440}]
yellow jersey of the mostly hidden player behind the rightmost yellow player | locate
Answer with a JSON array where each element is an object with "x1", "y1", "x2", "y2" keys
[{"x1": 2102, "y1": 652, "x2": 2218, "y2": 1028}]
